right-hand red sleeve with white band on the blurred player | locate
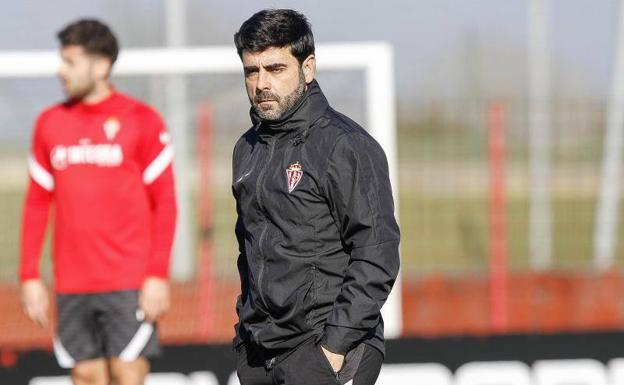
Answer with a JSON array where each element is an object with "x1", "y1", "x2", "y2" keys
[{"x1": 140, "y1": 110, "x2": 177, "y2": 279}]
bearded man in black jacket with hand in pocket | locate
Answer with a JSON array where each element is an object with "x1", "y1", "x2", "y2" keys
[{"x1": 232, "y1": 9, "x2": 399, "y2": 385}]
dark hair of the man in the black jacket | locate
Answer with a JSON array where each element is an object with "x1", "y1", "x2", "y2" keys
[{"x1": 234, "y1": 9, "x2": 314, "y2": 63}]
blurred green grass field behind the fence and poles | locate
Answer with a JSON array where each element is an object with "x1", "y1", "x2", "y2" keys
[{"x1": 0, "y1": 177, "x2": 624, "y2": 281}]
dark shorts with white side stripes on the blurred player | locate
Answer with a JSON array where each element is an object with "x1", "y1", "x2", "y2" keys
[{"x1": 54, "y1": 290, "x2": 160, "y2": 368}]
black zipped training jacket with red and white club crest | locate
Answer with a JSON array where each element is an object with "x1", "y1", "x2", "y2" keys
[{"x1": 232, "y1": 81, "x2": 399, "y2": 353}]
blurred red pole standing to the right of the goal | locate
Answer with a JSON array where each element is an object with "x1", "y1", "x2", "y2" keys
[{"x1": 488, "y1": 103, "x2": 508, "y2": 332}]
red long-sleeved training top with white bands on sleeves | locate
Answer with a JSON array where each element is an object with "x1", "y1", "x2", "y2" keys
[{"x1": 20, "y1": 91, "x2": 176, "y2": 294}]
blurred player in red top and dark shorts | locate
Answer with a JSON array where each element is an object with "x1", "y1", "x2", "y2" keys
[{"x1": 20, "y1": 20, "x2": 176, "y2": 385}]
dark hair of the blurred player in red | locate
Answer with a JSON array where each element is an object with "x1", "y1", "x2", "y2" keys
[{"x1": 56, "y1": 19, "x2": 119, "y2": 64}]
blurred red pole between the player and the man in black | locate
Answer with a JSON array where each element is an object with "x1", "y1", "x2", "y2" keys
[{"x1": 197, "y1": 102, "x2": 217, "y2": 342}]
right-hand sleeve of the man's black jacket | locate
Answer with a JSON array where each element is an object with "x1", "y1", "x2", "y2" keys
[{"x1": 321, "y1": 132, "x2": 399, "y2": 354}]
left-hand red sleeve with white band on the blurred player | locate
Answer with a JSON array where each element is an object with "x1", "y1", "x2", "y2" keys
[{"x1": 19, "y1": 114, "x2": 55, "y2": 282}]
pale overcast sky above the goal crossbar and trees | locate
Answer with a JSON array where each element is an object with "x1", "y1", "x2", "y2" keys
[{"x1": 0, "y1": 0, "x2": 618, "y2": 97}]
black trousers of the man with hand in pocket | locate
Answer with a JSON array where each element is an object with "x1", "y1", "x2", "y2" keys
[{"x1": 236, "y1": 338, "x2": 383, "y2": 385}]
